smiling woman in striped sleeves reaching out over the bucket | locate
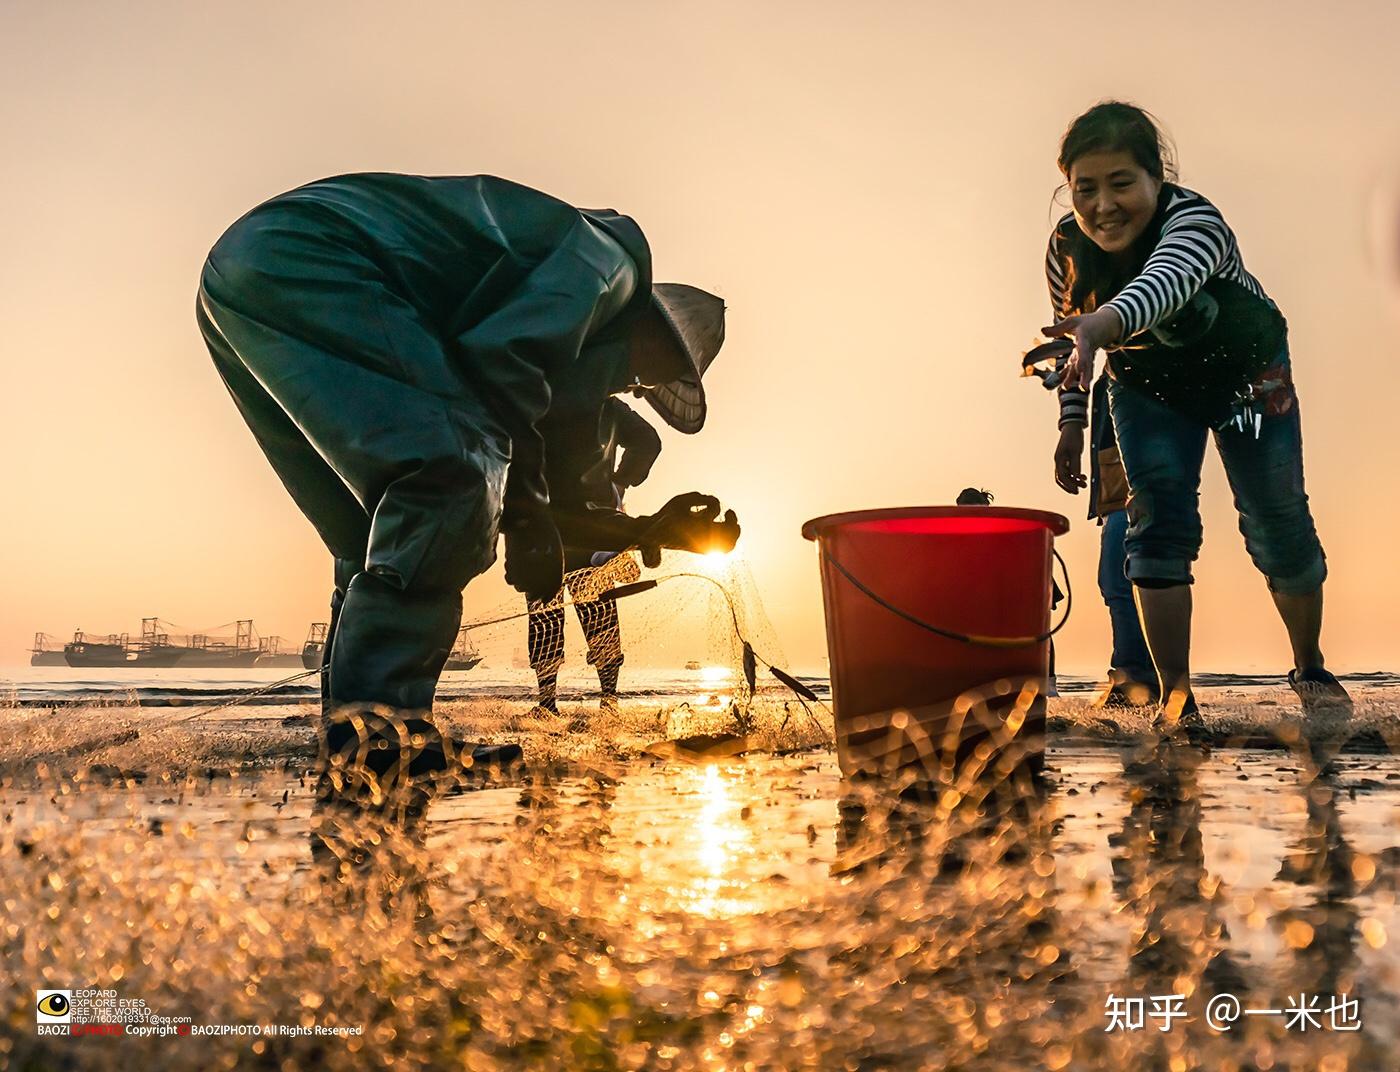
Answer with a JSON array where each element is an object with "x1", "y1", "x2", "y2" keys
[{"x1": 1044, "y1": 101, "x2": 1350, "y2": 726}]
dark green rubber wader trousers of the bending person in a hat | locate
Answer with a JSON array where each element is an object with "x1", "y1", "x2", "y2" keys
[{"x1": 197, "y1": 204, "x2": 510, "y2": 710}]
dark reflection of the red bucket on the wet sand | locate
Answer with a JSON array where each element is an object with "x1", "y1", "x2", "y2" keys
[{"x1": 833, "y1": 761, "x2": 1085, "y2": 1068}]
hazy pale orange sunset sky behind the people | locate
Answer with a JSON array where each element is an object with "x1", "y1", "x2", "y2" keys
[{"x1": 0, "y1": 0, "x2": 1400, "y2": 672}]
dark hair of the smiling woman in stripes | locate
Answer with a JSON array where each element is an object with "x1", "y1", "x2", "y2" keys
[{"x1": 1057, "y1": 101, "x2": 1176, "y2": 315}]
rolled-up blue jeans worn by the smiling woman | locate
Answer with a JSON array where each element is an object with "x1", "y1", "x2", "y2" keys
[{"x1": 1109, "y1": 351, "x2": 1327, "y2": 595}]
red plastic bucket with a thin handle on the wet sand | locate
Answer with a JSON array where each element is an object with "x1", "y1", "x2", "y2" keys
[{"x1": 802, "y1": 507, "x2": 1070, "y2": 774}]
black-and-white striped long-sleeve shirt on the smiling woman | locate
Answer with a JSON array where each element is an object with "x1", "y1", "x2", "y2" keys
[{"x1": 1046, "y1": 183, "x2": 1273, "y2": 427}]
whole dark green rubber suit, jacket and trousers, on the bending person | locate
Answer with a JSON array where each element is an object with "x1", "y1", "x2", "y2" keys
[{"x1": 197, "y1": 174, "x2": 651, "y2": 710}]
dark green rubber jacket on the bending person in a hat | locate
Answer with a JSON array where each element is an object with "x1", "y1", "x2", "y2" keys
[{"x1": 264, "y1": 174, "x2": 651, "y2": 511}]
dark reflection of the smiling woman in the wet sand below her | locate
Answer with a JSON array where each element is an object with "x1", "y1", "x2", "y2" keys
[{"x1": 1110, "y1": 726, "x2": 1376, "y2": 1069}]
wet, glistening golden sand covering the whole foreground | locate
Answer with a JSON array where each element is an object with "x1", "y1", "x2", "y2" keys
[{"x1": 0, "y1": 689, "x2": 1400, "y2": 1072}]
